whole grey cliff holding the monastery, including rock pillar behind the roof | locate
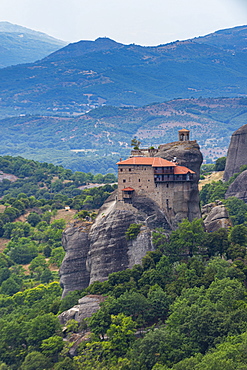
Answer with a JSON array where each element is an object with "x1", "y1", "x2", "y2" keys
[{"x1": 60, "y1": 141, "x2": 202, "y2": 296}]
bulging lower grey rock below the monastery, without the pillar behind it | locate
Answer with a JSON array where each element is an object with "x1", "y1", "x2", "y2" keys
[{"x1": 60, "y1": 194, "x2": 171, "y2": 297}]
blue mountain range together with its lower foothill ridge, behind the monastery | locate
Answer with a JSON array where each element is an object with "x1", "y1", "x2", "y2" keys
[{"x1": 0, "y1": 26, "x2": 247, "y2": 173}]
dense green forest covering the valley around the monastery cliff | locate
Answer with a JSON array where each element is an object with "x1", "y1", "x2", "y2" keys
[{"x1": 0, "y1": 157, "x2": 247, "y2": 370}]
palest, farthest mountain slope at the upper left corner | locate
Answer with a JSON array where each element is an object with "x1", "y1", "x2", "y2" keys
[{"x1": 0, "y1": 22, "x2": 66, "y2": 68}]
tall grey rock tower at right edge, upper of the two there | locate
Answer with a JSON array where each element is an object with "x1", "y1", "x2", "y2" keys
[{"x1": 223, "y1": 125, "x2": 247, "y2": 181}]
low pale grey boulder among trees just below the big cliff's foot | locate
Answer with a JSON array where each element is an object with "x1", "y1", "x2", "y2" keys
[{"x1": 58, "y1": 294, "x2": 105, "y2": 325}]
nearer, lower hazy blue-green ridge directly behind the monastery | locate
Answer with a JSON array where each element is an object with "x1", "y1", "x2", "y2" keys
[{"x1": 0, "y1": 98, "x2": 247, "y2": 173}]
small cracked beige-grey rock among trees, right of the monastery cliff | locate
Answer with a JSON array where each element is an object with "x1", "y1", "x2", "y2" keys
[{"x1": 202, "y1": 201, "x2": 231, "y2": 233}]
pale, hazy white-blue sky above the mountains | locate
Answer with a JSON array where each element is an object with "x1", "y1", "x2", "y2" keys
[{"x1": 0, "y1": 0, "x2": 247, "y2": 45}]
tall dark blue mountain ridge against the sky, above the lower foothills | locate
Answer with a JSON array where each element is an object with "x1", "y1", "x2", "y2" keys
[{"x1": 0, "y1": 26, "x2": 247, "y2": 117}]
